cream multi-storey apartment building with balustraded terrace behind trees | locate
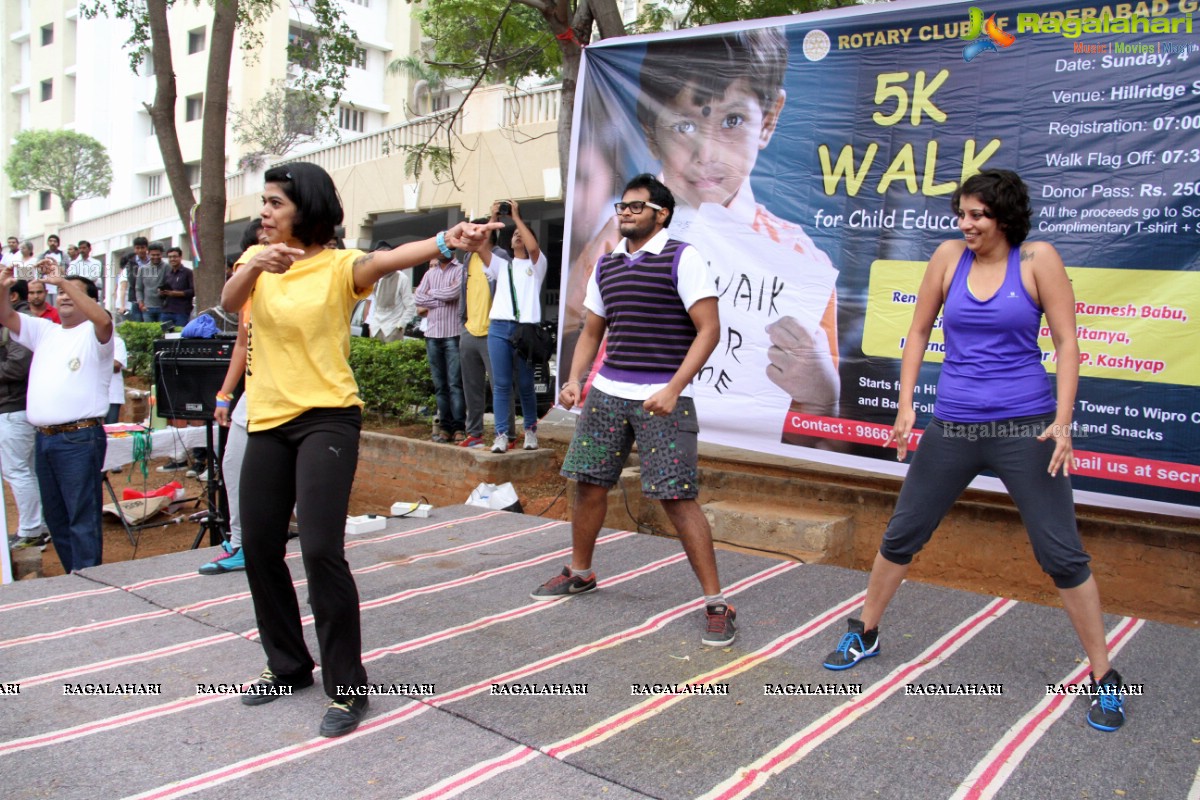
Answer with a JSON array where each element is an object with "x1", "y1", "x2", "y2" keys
[{"x1": 0, "y1": 0, "x2": 562, "y2": 299}]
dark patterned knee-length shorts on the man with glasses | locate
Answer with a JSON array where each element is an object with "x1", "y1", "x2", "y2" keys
[{"x1": 563, "y1": 387, "x2": 700, "y2": 500}]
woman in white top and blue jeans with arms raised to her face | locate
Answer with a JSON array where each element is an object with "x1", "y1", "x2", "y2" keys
[{"x1": 487, "y1": 200, "x2": 546, "y2": 453}]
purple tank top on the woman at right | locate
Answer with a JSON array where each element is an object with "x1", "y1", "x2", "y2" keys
[{"x1": 934, "y1": 247, "x2": 1057, "y2": 422}]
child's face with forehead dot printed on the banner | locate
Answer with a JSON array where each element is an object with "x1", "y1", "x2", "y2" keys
[{"x1": 649, "y1": 78, "x2": 784, "y2": 207}]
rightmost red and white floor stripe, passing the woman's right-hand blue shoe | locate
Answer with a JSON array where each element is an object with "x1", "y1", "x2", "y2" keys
[{"x1": 950, "y1": 616, "x2": 1145, "y2": 800}]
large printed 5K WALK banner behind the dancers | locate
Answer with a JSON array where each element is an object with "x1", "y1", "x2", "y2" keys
[{"x1": 558, "y1": 0, "x2": 1200, "y2": 516}]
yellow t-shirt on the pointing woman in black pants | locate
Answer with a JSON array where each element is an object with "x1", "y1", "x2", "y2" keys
[{"x1": 246, "y1": 249, "x2": 371, "y2": 433}]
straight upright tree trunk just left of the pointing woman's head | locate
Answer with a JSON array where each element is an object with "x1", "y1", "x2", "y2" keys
[{"x1": 195, "y1": 0, "x2": 238, "y2": 309}]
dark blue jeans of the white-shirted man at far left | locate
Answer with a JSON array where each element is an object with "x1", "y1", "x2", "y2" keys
[{"x1": 35, "y1": 426, "x2": 108, "y2": 573}]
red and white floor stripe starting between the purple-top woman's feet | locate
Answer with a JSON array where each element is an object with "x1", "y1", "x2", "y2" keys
[{"x1": 701, "y1": 597, "x2": 1016, "y2": 800}]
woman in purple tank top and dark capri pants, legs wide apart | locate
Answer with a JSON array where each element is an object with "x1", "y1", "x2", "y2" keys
[{"x1": 824, "y1": 169, "x2": 1124, "y2": 730}]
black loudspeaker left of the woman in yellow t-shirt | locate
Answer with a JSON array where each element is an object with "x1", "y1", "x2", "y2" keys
[{"x1": 154, "y1": 339, "x2": 241, "y2": 421}]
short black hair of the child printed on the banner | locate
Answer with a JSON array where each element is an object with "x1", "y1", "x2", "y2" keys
[{"x1": 637, "y1": 28, "x2": 787, "y2": 149}]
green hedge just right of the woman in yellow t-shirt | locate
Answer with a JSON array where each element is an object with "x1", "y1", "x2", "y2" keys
[{"x1": 350, "y1": 337, "x2": 434, "y2": 422}]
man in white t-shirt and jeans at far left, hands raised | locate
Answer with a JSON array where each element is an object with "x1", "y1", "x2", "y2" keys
[{"x1": 0, "y1": 266, "x2": 114, "y2": 573}]
